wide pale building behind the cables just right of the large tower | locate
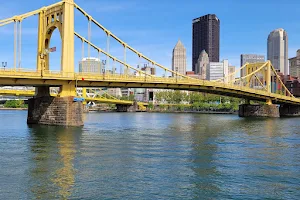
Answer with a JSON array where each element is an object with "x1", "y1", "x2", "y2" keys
[{"x1": 79, "y1": 57, "x2": 102, "y2": 74}]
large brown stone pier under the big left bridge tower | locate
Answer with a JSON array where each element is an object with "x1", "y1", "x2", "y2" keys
[{"x1": 27, "y1": 96, "x2": 83, "y2": 126}]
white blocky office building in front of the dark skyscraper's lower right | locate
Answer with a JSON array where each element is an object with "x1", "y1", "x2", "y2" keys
[{"x1": 206, "y1": 60, "x2": 228, "y2": 83}]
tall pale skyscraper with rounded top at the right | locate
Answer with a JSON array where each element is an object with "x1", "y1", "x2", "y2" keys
[{"x1": 268, "y1": 28, "x2": 289, "y2": 75}]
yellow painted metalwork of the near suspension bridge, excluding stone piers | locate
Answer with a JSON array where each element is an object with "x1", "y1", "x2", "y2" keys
[{"x1": 0, "y1": 0, "x2": 300, "y2": 104}]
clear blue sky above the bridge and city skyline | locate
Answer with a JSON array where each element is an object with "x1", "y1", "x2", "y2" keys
[{"x1": 0, "y1": 0, "x2": 300, "y2": 74}]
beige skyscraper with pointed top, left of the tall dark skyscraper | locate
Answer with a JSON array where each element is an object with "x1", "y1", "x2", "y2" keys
[{"x1": 172, "y1": 40, "x2": 186, "y2": 76}]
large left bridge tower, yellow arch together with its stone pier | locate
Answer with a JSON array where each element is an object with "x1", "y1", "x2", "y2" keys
[{"x1": 27, "y1": 0, "x2": 83, "y2": 126}]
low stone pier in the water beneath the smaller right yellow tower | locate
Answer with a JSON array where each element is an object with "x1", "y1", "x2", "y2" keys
[{"x1": 239, "y1": 104, "x2": 280, "y2": 117}]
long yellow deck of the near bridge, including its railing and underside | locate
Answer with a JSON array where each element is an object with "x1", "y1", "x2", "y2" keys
[{"x1": 0, "y1": 69, "x2": 300, "y2": 105}]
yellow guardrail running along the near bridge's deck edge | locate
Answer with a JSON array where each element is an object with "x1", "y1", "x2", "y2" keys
[{"x1": 0, "y1": 68, "x2": 300, "y2": 103}]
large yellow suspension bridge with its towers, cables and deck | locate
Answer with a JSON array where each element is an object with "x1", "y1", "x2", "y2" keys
[{"x1": 0, "y1": 0, "x2": 300, "y2": 125}]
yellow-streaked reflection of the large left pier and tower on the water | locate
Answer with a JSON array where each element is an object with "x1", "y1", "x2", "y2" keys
[{"x1": 29, "y1": 125, "x2": 82, "y2": 199}]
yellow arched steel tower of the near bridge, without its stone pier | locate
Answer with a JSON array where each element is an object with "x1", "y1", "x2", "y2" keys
[{"x1": 37, "y1": 0, "x2": 75, "y2": 96}]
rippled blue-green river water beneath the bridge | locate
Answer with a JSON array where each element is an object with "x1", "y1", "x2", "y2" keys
[{"x1": 0, "y1": 111, "x2": 300, "y2": 199}]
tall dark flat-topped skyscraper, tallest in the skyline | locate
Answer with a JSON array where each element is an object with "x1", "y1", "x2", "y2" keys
[{"x1": 192, "y1": 14, "x2": 220, "y2": 71}]
